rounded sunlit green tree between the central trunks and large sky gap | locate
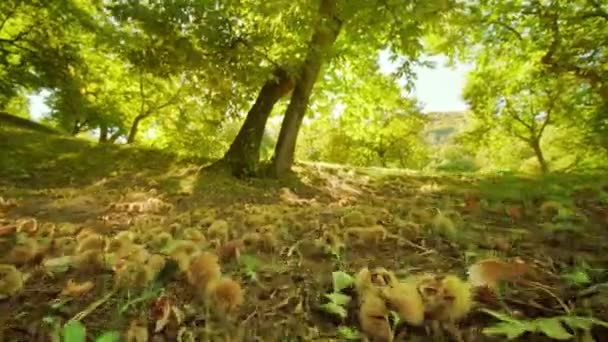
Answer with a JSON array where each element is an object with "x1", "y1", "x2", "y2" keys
[{"x1": 298, "y1": 60, "x2": 426, "y2": 168}]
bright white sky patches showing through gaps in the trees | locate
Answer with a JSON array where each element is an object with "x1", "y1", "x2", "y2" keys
[{"x1": 29, "y1": 53, "x2": 472, "y2": 120}]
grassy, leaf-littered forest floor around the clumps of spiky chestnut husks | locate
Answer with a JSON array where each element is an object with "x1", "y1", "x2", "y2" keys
[{"x1": 0, "y1": 128, "x2": 608, "y2": 341}]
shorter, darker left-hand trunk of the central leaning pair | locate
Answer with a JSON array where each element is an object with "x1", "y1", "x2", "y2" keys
[{"x1": 211, "y1": 69, "x2": 293, "y2": 177}]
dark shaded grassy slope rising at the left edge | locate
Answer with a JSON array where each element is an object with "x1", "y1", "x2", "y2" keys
[{"x1": 0, "y1": 127, "x2": 179, "y2": 189}]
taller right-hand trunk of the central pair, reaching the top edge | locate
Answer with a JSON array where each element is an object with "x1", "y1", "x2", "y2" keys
[{"x1": 270, "y1": 0, "x2": 342, "y2": 177}]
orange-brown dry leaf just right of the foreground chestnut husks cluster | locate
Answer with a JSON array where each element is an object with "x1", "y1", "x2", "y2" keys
[{"x1": 468, "y1": 258, "x2": 529, "y2": 290}]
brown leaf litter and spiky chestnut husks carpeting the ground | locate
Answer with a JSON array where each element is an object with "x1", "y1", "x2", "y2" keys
[{"x1": 0, "y1": 152, "x2": 608, "y2": 341}]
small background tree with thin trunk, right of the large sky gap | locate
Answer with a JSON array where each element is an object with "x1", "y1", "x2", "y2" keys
[{"x1": 464, "y1": 59, "x2": 567, "y2": 172}]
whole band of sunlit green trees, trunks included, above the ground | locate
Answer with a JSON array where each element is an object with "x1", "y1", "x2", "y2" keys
[{"x1": 0, "y1": 0, "x2": 608, "y2": 176}]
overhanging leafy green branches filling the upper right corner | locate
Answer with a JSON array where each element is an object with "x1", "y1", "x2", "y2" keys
[{"x1": 430, "y1": 0, "x2": 608, "y2": 155}]
